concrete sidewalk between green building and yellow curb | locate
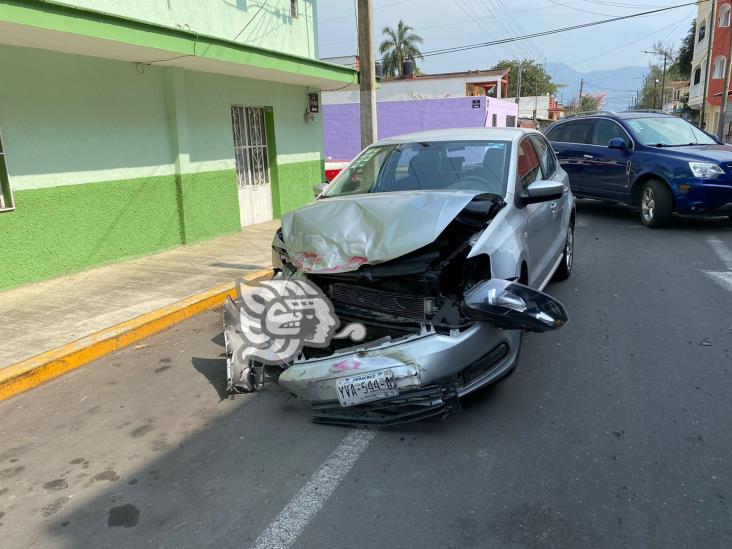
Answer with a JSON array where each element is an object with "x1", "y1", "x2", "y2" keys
[{"x1": 0, "y1": 220, "x2": 279, "y2": 371}]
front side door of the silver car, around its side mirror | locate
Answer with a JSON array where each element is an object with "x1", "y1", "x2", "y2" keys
[{"x1": 517, "y1": 136, "x2": 555, "y2": 287}]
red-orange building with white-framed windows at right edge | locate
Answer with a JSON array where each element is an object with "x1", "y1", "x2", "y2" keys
[{"x1": 705, "y1": 0, "x2": 732, "y2": 137}]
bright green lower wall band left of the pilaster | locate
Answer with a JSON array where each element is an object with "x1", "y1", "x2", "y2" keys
[{"x1": 0, "y1": 176, "x2": 182, "y2": 288}]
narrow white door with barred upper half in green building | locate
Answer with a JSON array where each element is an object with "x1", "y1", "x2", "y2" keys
[{"x1": 231, "y1": 106, "x2": 273, "y2": 227}]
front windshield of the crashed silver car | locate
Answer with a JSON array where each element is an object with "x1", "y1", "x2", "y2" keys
[{"x1": 324, "y1": 141, "x2": 511, "y2": 197}]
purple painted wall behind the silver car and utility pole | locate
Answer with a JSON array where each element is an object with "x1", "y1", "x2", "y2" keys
[{"x1": 323, "y1": 97, "x2": 518, "y2": 160}]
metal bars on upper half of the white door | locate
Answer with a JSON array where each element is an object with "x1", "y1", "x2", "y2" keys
[{"x1": 231, "y1": 106, "x2": 270, "y2": 189}]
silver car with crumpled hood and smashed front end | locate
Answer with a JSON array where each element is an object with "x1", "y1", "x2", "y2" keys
[{"x1": 224, "y1": 128, "x2": 575, "y2": 424}]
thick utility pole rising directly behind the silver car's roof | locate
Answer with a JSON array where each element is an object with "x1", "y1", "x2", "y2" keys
[{"x1": 358, "y1": 0, "x2": 374, "y2": 149}]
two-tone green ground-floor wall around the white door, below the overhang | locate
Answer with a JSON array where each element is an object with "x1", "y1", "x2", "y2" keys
[{"x1": 0, "y1": 46, "x2": 322, "y2": 289}]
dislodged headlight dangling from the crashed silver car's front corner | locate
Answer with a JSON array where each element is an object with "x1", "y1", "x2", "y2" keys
[{"x1": 463, "y1": 278, "x2": 568, "y2": 332}]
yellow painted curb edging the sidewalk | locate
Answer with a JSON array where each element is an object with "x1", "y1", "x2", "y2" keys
[{"x1": 0, "y1": 269, "x2": 272, "y2": 401}]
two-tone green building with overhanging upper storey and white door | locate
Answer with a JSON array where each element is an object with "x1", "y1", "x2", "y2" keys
[{"x1": 0, "y1": 0, "x2": 358, "y2": 288}]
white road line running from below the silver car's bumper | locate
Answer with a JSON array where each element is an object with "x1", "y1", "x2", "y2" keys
[{"x1": 253, "y1": 430, "x2": 376, "y2": 549}]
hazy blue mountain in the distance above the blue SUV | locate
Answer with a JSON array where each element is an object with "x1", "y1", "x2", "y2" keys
[{"x1": 546, "y1": 63, "x2": 648, "y2": 111}]
